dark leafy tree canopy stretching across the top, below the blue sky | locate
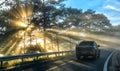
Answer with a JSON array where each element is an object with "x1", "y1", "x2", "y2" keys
[{"x1": 0, "y1": 0, "x2": 112, "y2": 34}]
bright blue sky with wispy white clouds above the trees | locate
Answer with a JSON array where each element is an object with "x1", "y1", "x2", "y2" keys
[{"x1": 65, "y1": 0, "x2": 120, "y2": 25}]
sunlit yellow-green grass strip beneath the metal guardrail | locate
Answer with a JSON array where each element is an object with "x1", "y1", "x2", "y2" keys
[{"x1": 0, "y1": 53, "x2": 74, "y2": 69}]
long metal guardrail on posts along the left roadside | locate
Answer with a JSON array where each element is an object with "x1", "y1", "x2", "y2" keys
[{"x1": 0, "y1": 50, "x2": 74, "y2": 68}]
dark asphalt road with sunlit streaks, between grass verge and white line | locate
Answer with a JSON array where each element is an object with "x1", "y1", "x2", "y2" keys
[{"x1": 4, "y1": 49, "x2": 112, "y2": 71}]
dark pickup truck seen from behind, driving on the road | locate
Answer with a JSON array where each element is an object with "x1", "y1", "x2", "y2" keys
[{"x1": 76, "y1": 41, "x2": 100, "y2": 59}]
